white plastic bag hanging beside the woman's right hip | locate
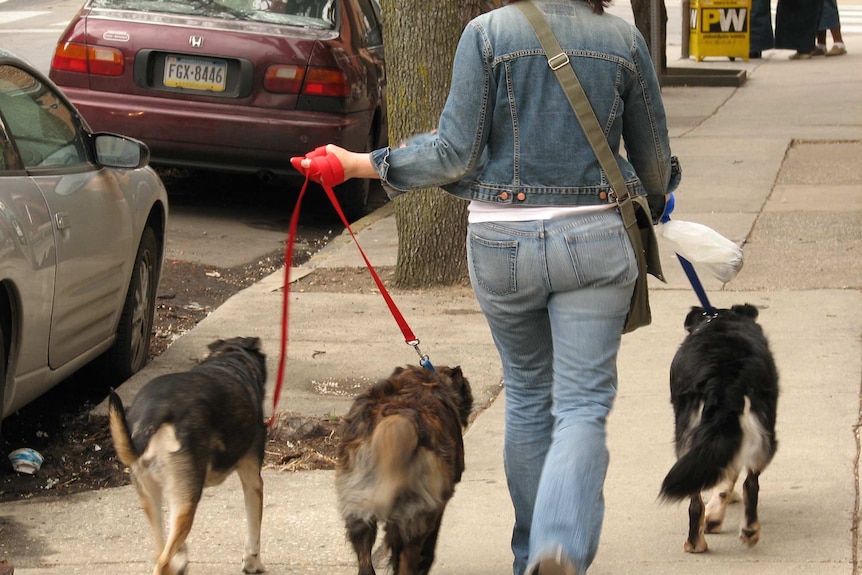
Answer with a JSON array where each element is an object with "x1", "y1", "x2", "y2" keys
[{"x1": 656, "y1": 220, "x2": 743, "y2": 283}]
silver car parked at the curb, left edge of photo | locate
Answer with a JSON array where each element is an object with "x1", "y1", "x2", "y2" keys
[{"x1": 0, "y1": 49, "x2": 168, "y2": 424}]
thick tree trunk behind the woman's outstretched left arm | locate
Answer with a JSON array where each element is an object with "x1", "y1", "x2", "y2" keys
[{"x1": 380, "y1": 0, "x2": 502, "y2": 288}]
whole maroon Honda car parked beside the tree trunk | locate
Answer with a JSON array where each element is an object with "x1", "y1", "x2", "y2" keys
[{"x1": 50, "y1": 0, "x2": 387, "y2": 218}]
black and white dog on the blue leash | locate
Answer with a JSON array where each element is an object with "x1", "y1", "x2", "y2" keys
[{"x1": 661, "y1": 304, "x2": 778, "y2": 553}]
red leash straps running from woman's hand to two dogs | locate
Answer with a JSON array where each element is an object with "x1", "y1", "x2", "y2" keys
[{"x1": 266, "y1": 168, "x2": 434, "y2": 427}]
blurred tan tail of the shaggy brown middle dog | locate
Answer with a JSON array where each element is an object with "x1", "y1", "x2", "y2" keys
[{"x1": 371, "y1": 414, "x2": 419, "y2": 517}]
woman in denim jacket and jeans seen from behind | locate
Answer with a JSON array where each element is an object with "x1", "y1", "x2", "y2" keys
[{"x1": 292, "y1": 0, "x2": 679, "y2": 575}]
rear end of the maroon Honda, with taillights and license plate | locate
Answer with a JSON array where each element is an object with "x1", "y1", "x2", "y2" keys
[{"x1": 46, "y1": 2, "x2": 372, "y2": 173}]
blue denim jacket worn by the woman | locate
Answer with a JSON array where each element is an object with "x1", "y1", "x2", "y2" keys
[{"x1": 371, "y1": 0, "x2": 679, "y2": 206}]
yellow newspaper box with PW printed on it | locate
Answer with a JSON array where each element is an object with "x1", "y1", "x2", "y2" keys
[{"x1": 689, "y1": 0, "x2": 751, "y2": 62}]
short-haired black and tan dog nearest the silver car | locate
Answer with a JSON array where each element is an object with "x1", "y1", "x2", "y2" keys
[{"x1": 109, "y1": 337, "x2": 266, "y2": 575}]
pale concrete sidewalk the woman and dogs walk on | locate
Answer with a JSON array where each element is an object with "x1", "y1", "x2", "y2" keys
[{"x1": 0, "y1": 35, "x2": 862, "y2": 575}]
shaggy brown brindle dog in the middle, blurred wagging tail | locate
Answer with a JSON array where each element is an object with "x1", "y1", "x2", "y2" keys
[{"x1": 335, "y1": 366, "x2": 473, "y2": 575}]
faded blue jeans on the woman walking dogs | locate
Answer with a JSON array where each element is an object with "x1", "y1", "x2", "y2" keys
[{"x1": 467, "y1": 210, "x2": 638, "y2": 575}]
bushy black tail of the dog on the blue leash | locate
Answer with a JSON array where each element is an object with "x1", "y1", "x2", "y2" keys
[{"x1": 660, "y1": 392, "x2": 743, "y2": 501}]
